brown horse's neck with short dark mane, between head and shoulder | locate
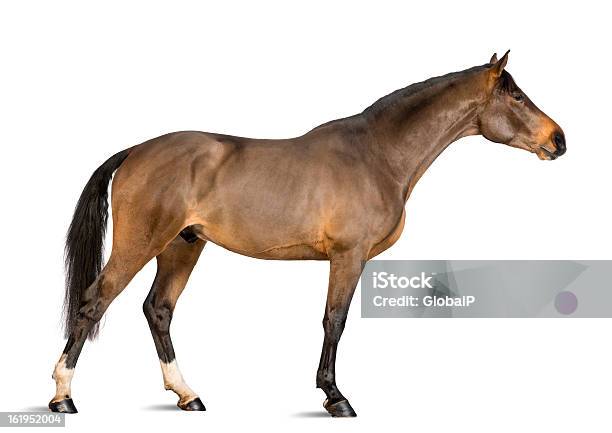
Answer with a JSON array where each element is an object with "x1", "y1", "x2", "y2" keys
[{"x1": 364, "y1": 69, "x2": 488, "y2": 200}]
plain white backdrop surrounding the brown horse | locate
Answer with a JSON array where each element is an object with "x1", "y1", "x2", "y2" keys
[{"x1": 0, "y1": 1, "x2": 612, "y2": 432}]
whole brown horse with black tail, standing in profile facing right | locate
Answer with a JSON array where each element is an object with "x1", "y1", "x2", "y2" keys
[{"x1": 49, "y1": 49, "x2": 565, "y2": 416}]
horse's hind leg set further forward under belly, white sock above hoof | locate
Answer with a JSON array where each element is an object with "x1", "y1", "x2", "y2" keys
[{"x1": 143, "y1": 232, "x2": 206, "y2": 411}]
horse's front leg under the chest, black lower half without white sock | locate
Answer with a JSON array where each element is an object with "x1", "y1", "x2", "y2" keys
[{"x1": 317, "y1": 249, "x2": 365, "y2": 417}]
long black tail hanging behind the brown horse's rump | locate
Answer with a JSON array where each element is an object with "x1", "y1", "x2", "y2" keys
[{"x1": 64, "y1": 149, "x2": 131, "y2": 339}]
